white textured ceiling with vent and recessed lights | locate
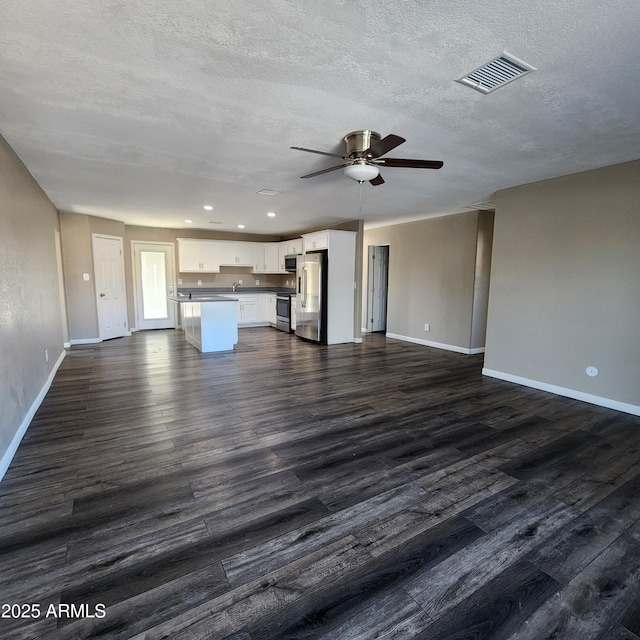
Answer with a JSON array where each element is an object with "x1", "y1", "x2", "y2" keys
[{"x1": 0, "y1": 0, "x2": 640, "y2": 235}]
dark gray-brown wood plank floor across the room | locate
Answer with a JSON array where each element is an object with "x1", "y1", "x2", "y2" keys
[{"x1": 0, "y1": 329, "x2": 640, "y2": 640}]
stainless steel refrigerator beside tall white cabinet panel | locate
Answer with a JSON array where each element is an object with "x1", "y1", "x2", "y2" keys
[{"x1": 296, "y1": 251, "x2": 327, "y2": 344}]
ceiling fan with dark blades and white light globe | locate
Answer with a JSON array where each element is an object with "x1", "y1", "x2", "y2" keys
[{"x1": 291, "y1": 129, "x2": 444, "y2": 186}]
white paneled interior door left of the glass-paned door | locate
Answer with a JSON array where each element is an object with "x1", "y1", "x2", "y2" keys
[{"x1": 92, "y1": 233, "x2": 129, "y2": 340}]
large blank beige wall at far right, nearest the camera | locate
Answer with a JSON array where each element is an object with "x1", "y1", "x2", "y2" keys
[{"x1": 485, "y1": 161, "x2": 640, "y2": 412}]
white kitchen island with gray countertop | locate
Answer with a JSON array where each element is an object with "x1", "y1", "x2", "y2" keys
[{"x1": 168, "y1": 295, "x2": 238, "y2": 353}]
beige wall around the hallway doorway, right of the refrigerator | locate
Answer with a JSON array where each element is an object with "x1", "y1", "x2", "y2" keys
[{"x1": 362, "y1": 211, "x2": 490, "y2": 349}]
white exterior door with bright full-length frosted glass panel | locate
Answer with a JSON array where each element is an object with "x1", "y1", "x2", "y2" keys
[{"x1": 132, "y1": 242, "x2": 178, "y2": 330}]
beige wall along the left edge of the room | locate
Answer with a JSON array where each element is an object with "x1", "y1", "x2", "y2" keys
[{"x1": 0, "y1": 137, "x2": 64, "y2": 477}]
